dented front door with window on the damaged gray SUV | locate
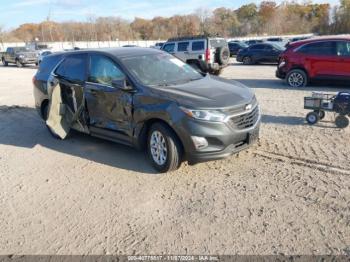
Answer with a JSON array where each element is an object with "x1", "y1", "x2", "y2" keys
[{"x1": 85, "y1": 54, "x2": 133, "y2": 140}]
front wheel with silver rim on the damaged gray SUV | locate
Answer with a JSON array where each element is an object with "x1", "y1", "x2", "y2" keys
[{"x1": 147, "y1": 123, "x2": 182, "y2": 173}]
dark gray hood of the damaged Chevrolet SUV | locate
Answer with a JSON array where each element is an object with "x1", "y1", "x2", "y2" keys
[{"x1": 152, "y1": 75, "x2": 254, "y2": 109}]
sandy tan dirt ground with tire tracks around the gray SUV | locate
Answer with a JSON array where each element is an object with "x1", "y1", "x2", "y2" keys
[{"x1": 0, "y1": 61, "x2": 350, "y2": 255}]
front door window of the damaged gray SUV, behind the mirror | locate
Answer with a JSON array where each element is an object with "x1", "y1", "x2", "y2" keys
[{"x1": 88, "y1": 55, "x2": 125, "y2": 86}]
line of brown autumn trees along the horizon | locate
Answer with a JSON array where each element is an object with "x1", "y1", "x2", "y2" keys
[{"x1": 0, "y1": 0, "x2": 350, "y2": 42}]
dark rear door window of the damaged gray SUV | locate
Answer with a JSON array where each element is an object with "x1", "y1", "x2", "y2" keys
[{"x1": 55, "y1": 54, "x2": 86, "y2": 82}]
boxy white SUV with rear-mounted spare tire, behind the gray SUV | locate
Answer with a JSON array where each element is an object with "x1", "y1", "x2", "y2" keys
[{"x1": 162, "y1": 36, "x2": 230, "y2": 75}]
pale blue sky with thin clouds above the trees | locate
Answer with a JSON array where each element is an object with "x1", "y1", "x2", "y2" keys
[{"x1": 0, "y1": 0, "x2": 339, "y2": 29}]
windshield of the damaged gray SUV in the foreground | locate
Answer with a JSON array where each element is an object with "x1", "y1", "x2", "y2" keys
[{"x1": 122, "y1": 53, "x2": 203, "y2": 86}]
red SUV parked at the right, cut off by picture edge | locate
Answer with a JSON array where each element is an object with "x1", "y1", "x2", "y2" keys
[{"x1": 276, "y1": 36, "x2": 350, "y2": 87}]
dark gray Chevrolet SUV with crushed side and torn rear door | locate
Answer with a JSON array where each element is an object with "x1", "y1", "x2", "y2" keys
[{"x1": 33, "y1": 48, "x2": 260, "y2": 172}]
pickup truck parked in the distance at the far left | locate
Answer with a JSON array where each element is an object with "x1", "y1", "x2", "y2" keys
[{"x1": 0, "y1": 47, "x2": 38, "y2": 67}]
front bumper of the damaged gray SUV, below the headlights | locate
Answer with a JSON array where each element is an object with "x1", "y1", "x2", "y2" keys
[{"x1": 177, "y1": 109, "x2": 261, "y2": 164}]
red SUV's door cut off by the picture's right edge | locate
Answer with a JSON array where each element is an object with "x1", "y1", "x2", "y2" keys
[{"x1": 335, "y1": 40, "x2": 350, "y2": 79}]
